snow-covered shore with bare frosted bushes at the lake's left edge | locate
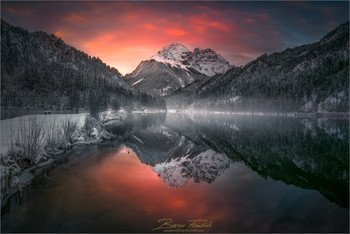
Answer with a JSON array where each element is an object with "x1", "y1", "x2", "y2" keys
[{"x1": 0, "y1": 112, "x2": 119, "y2": 206}]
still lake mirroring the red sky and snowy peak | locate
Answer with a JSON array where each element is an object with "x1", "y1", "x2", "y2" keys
[{"x1": 1, "y1": 114, "x2": 349, "y2": 233}]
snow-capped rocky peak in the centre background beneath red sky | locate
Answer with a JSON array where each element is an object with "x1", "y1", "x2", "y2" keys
[{"x1": 125, "y1": 43, "x2": 232, "y2": 96}]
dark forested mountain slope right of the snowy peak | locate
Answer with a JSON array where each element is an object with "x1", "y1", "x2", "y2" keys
[{"x1": 167, "y1": 22, "x2": 349, "y2": 112}]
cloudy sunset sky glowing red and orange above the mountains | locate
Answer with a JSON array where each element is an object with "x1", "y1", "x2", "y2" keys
[{"x1": 1, "y1": 1, "x2": 349, "y2": 74}]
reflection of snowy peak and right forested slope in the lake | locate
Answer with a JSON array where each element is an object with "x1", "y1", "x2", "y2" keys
[{"x1": 117, "y1": 115, "x2": 349, "y2": 207}]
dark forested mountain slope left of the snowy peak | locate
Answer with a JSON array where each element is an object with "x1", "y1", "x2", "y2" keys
[{"x1": 1, "y1": 19, "x2": 165, "y2": 111}]
